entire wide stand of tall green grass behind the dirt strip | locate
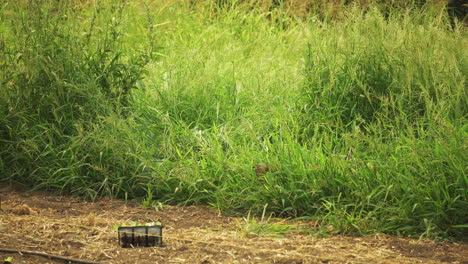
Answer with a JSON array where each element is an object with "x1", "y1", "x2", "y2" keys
[{"x1": 0, "y1": 1, "x2": 468, "y2": 238}]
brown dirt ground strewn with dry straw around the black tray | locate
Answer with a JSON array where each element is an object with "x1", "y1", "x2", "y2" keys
[{"x1": 0, "y1": 188, "x2": 468, "y2": 264}]
